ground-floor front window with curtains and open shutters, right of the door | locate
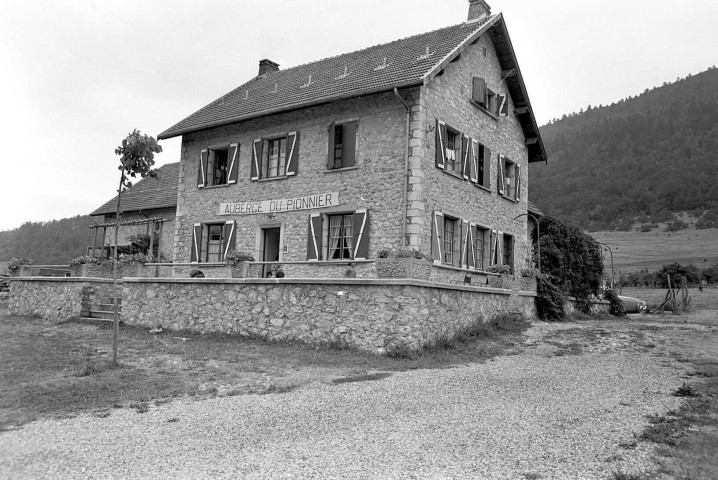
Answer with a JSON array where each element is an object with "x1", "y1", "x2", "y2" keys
[{"x1": 307, "y1": 209, "x2": 369, "y2": 260}]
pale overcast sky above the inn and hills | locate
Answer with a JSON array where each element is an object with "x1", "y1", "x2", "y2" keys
[{"x1": 0, "y1": 0, "x2": 718, "y2": 230}]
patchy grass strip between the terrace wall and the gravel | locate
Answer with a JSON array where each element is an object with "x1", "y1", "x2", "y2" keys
[{"x1": 0, "y1": 314, "x2": 529, "y2": 432}]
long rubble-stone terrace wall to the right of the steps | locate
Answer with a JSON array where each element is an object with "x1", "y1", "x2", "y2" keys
[{"x1": 123, "y1": 279, "x2": 535, "y2": 352}]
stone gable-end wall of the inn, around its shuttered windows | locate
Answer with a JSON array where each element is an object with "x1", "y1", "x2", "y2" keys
[{"x1": 416, "y1": 33, "x2": 529, "y2": 271}]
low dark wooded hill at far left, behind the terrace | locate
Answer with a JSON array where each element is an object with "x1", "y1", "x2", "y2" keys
[{"x1": 0, "y1": 215, "x2": 95, "y2": 265}]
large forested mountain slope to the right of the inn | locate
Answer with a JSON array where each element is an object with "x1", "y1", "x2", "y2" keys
[{"x1": 530, "y1": 67, "x2": 718, "y2": 230}]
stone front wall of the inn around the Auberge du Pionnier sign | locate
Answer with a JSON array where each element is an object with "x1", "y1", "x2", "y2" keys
[{"x1": 174, "y1": 91, "x2": 418, "y2": 264}]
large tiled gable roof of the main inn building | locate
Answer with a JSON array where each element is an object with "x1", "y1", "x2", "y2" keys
[{"x1": 158, "y1": 14, "x2": 546, "y2": 161}]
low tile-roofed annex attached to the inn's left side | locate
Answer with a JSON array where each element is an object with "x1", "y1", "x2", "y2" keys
[{"x1": 90, "y1": 162, "x2": 180, "y2": 260}]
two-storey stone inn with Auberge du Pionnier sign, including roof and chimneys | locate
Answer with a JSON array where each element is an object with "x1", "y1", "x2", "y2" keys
[{"x1": 160, "y1": 0, "x2": 546, "y2": 277}]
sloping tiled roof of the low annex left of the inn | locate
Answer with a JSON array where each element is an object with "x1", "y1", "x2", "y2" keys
[{"x1": 90, "y1": 162, "x2": 179, "y2": 215}]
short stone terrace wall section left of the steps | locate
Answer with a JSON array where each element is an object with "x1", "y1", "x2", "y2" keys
[{"x1": 8, "y1": 277, "x2": 112, "y2": 322}]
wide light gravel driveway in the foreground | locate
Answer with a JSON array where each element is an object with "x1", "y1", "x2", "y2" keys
[{"x1": 0, "y1": 323, "x2": 686, "y2": 479}]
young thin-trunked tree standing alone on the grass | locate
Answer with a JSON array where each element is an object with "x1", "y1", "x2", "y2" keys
[{"x1": 112, "y1": 129, "x2": 162, "y2": 365}]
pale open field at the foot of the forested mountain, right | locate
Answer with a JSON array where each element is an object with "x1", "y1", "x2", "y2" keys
[{"x1": 590, "y1": 228, "x2": 718, "y2": 275}]
